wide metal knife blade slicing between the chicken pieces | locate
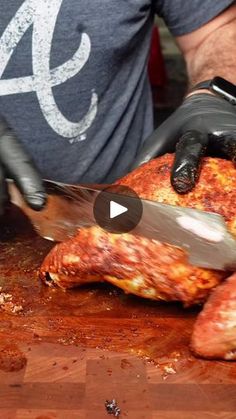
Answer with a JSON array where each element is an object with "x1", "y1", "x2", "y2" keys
[{"x1": 8, "y1": 180, "x2": 236, "y2": 271}]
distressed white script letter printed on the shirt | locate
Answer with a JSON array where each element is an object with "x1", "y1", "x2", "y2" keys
[{"x1": 0, "y1": 0, "x2": 98, "y2": 142}]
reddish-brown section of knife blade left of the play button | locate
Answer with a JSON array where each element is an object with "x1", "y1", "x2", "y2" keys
[{"x1": 8, "y1": 181, "x2": 103, "y2": 241}]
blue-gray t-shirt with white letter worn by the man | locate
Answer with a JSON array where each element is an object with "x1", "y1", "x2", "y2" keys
[{"x1": 0, "y1": 0, "x2": 233, "y2": 183}]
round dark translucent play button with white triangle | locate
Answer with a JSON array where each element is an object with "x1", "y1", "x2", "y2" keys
[{"x1": 93, "y1": 185, "x2": 143, "y2": 233}]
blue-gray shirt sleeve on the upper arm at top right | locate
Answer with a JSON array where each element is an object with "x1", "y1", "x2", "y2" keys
[{"x1": 154, "y1": 0, "x2": 236, "y2": 36}]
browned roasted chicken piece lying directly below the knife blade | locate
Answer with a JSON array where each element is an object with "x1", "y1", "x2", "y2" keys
[{"x1": 41, "y1": 227, "x2": 226, "y2": 305}]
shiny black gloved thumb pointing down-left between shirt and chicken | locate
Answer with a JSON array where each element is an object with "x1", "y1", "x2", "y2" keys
[{"x1": 131, "y1": 110, "x2": 181, "y2": 170}]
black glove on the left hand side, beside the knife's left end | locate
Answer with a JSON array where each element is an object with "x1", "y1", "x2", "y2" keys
[{"x1": 0, "y1": 119, "x2": 46, "y2": 215}]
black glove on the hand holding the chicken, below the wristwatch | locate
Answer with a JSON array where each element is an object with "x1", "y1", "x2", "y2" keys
[{"x1": 132, "y1": 93, "x2": 236, "y2": 193}]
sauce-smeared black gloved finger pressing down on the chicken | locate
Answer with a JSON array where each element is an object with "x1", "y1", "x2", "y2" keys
[{"x1": 171, "y1": 130, "x2": 208, "y2": 194}]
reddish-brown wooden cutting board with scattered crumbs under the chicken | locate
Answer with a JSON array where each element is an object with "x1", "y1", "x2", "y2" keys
[{"x1": 0, "y1": 208, "x2": 236, "y2": 419}]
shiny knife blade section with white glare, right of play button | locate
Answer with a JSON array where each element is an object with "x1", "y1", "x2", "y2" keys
[{"x1": 133, "y1": 200, "x2": 236, "y2": 271}]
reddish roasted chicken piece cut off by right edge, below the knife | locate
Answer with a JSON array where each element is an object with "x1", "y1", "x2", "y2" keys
[{"x1": 191, "y1": 274, "x2": 236, "y2": 361}]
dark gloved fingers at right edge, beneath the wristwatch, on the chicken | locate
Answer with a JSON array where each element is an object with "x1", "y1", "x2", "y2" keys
[{"x1": 209, "y1": 132, "x2": 236, "y2": 163}]
